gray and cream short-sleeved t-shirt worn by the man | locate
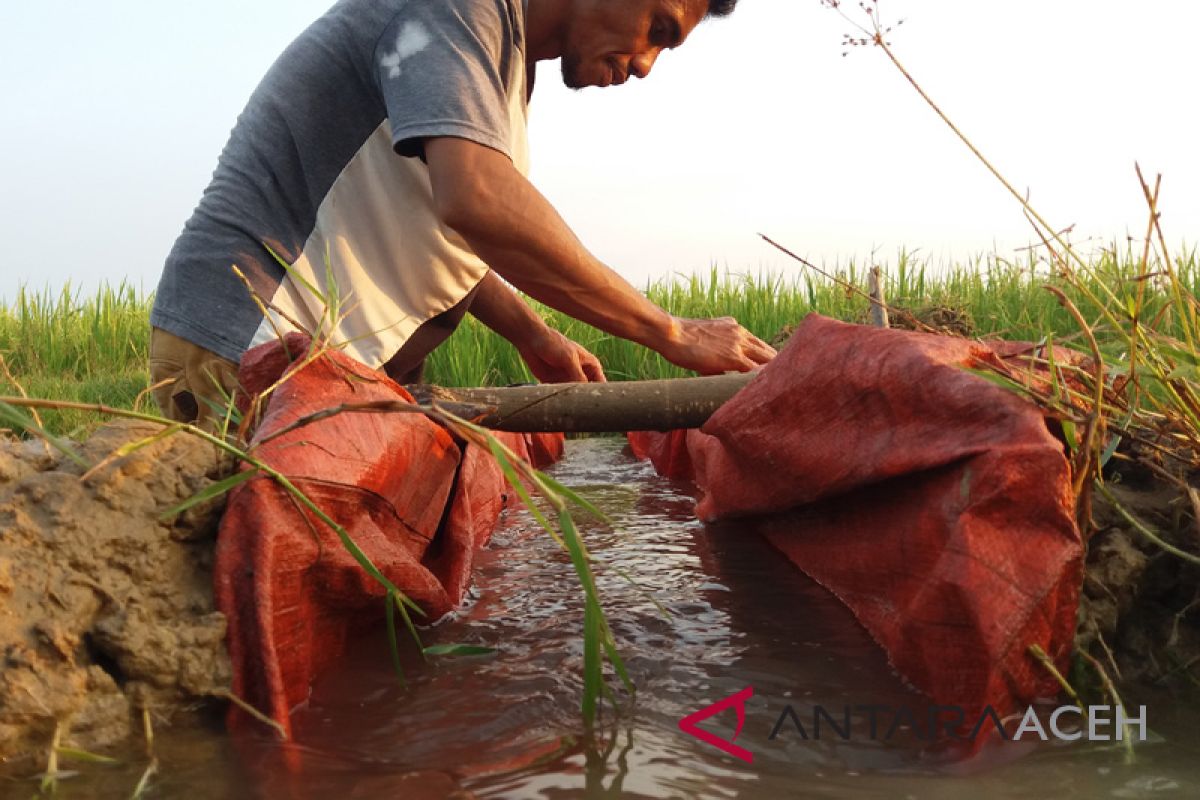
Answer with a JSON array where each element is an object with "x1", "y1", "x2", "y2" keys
[{"x1": 150, "y1": 0, "x2": 528, "y2": 367}]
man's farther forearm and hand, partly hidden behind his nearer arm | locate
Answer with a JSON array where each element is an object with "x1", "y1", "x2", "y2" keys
[{"x1": 470, "y1": 271, "x2": 605, "y2": 384}]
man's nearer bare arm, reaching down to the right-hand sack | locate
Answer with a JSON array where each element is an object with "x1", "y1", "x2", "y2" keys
[{"x1": 425, "y1": 138, "x2": 775, "y2": 374}]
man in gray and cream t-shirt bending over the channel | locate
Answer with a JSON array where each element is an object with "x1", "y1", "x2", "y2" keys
[{"x1": 150, "y1": 0, "x2": 774, "y2": 421}]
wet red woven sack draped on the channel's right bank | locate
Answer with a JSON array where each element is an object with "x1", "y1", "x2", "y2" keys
[{"x1": 630, "y1": 314, "x2": 1084, "y2": 734}]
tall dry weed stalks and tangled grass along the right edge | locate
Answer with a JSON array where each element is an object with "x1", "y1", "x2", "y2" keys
[{"x1": 821, "y1": 0, "x2": 1200, "y2": 738}]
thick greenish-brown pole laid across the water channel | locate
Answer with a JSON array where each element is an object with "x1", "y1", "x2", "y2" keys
[{"x1": 408, "y1": 372, "x2": 755, "y2": 433}]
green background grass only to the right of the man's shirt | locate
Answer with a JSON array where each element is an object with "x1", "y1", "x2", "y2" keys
[{"x1": 427, "y1": 251, "x2": 1200, "y2": 386}]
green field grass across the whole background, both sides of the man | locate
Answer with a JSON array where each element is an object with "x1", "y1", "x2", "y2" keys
[{"x1": 0, "y1": 249, "x2": 1200, "y2": 433}]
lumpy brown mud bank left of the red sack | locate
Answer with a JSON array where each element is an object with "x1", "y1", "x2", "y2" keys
[{"x1": 0, "y1": 422, "x2": 230, "y2": 763}]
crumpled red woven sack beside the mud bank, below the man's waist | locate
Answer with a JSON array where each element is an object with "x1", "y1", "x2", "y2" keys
[{"x1": 215, "y1": 333, "x2": 563, "y2": 734}]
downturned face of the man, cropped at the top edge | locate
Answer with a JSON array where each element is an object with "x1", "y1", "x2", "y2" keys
[{"x1": 563, "y1": 0, "x2": 708, "y2": 89}]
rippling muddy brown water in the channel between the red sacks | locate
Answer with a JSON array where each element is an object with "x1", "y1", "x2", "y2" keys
[{"x1": 28, "y1": 440, "x2": 1200, "y2": 798}]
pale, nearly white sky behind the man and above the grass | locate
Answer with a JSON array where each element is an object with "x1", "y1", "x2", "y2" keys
[{"x1": 0, "y1": 0, "x2": 1200, "y2": 303}]
